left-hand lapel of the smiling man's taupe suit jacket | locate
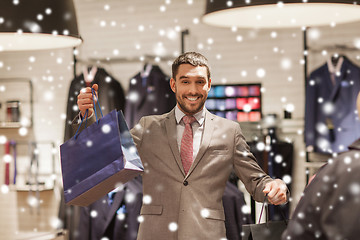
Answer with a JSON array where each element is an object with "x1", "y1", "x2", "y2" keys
[{"x1": 165, "y1": 108, "x2": 185, "y2": 176}]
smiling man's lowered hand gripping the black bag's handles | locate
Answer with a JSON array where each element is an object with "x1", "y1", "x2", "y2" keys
[{"x1": 263, "y1": 179, "x2": 287, "y2": 205}]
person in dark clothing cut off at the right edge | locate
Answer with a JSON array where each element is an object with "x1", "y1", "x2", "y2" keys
[{"x1": 282, "y1": 93, "x2": 360, "y2": 240}]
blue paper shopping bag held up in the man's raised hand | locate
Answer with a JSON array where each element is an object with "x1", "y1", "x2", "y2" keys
[{"x1": 60, "y1": 90, "x2": 144, "y2": 206}]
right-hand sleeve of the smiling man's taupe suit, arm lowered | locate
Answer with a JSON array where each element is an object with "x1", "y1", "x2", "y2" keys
[{"x1": 233, "y1": 124, "x2": 272, "y2": 202}]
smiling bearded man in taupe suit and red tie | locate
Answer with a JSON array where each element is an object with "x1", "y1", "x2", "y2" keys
[{"x1": 78, "y1": 52, "x2": 287, "y2": 240}]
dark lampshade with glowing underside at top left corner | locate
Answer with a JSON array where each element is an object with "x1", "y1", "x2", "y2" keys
[{"x1": 0, "y1": 0, "x2": 82, "y2": 51}]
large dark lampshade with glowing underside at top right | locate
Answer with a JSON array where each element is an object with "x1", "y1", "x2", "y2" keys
[{"x1": 203, "y1": 0, "x2": 360, "y2": 28}]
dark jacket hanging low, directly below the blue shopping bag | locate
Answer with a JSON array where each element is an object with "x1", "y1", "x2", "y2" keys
[{"x1": 76, "y1": 177, "x2": 143, "y2": 240}]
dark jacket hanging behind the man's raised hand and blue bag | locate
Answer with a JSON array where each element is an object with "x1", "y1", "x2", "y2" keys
[{"x1": 59, "y1": 68, "x2": 125, "y2": 240}]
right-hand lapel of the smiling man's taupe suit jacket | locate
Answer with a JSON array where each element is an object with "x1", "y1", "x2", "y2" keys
[{"x1": 186, "y1": 109, "x2": 215, "y2": 178}]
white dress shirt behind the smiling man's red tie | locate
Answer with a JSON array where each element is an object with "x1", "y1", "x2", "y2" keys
[{"x1": 175, "y1": 105, "x2": 205, "y2": 160}]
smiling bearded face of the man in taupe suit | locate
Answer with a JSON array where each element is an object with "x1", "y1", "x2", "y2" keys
[{"x1": 170, "y1": 64, "x2": 211, "y2": 115}]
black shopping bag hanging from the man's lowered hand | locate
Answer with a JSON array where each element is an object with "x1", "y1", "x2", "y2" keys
[{"x1": 242, "y1": 196, "x2": 287, "y2": 240}]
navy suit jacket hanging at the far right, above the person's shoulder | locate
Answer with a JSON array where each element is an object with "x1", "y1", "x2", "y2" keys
[{"x1": 305, "y1": 57, "x2": 360, "y2": 152}]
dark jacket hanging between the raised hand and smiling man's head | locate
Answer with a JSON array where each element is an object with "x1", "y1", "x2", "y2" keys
[{"x1": 125, "y1": 65, "x2": 176, "y2": 128}]
